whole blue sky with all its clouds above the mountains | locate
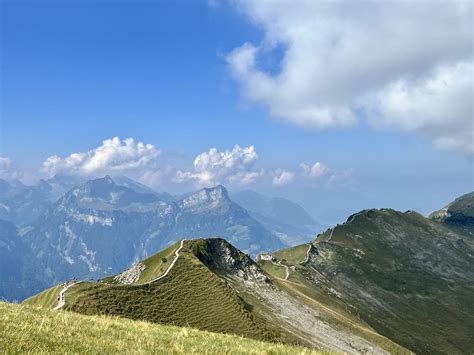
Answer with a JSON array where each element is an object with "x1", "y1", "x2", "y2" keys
[{"x1": 0, "y1": 0, "x2": 474, "y2": 224}]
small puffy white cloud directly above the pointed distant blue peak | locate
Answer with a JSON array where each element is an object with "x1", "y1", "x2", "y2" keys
[{"x1": 175, "y1": 145, "x2": 263, "y2": 186}]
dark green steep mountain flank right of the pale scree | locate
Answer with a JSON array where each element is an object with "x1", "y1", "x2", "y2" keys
[{"x1": 262, "y1": 209, "x2": 474, "y2": 353}]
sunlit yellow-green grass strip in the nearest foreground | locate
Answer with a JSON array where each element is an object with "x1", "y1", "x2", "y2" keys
[{"x1": 0, "y1": 302, "x2": 315, "y2": 354}]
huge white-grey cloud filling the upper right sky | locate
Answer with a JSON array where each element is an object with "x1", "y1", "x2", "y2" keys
[{"x1": 227, "y1": 0, "x2": 474, "y2": 154}]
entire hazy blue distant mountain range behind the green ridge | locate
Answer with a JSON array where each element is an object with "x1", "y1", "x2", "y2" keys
[{"x1": 0, "y1": 176, "x2": 318, "y2": 300}]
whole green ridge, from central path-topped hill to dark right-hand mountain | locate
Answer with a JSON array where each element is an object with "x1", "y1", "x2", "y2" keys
[{"x1": 24, "y1": 194, "x2": 474, "y2": 354}]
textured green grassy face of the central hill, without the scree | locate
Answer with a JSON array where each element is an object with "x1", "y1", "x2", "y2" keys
[{"x1": 26, "y1": 241, "x2": 301, "y2": 344}]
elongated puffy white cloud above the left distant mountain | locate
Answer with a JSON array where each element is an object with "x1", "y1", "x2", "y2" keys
[{"x1": 42, "y1": 137, "x2": 160, "y2": 176}]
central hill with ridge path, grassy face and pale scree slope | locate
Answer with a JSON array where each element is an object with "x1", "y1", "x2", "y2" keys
[{"x1": 25, "y1": 239, "x2": 406, "y2": 353}]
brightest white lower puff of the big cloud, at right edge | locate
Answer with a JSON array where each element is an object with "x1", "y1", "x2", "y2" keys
[{"x1": 372, "y1": 63, "x2": 474, "y2": 154}]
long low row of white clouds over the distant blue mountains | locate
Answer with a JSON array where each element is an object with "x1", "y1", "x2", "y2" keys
[{"x1": 0, "y1": 137, "x2": 351, "y2": 188}]
